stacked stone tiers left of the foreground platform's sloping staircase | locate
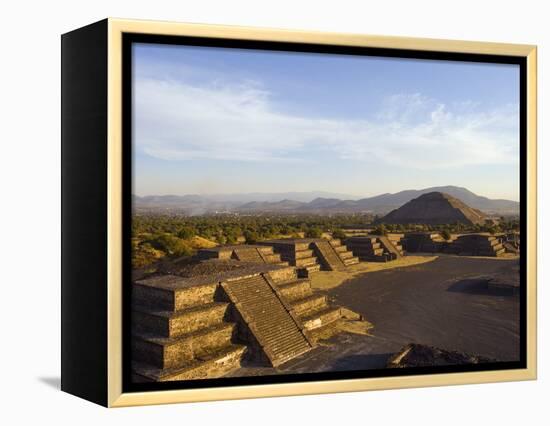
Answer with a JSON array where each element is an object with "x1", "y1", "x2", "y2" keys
[{"x1": 131, "y1": 275, "x2": 246, "y2": 382}]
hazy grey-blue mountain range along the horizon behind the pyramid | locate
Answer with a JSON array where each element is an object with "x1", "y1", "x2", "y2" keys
[{"x1": 133, "y1": 186, "x2": 519, "y2": 215}]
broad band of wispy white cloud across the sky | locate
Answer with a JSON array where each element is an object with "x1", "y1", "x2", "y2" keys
[{"x1": 134, "y1": 78, "x2": 519, "y2": 169}]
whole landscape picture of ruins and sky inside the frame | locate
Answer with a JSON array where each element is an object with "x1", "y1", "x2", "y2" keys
[{"x1": 129, "y1": 43, "x2": 523, "y2": 383}]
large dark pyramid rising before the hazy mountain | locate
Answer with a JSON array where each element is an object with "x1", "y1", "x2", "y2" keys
[{"x1": 378, "y1": 192, "x2": 485, "y2": 225}]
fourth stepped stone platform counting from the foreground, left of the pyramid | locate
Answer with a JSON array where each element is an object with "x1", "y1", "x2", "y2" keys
[{"x1": 346, "y1": 234, "x2": 404, "y2": 262}]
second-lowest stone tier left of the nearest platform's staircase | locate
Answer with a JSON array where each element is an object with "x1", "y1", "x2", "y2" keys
[{"x1": 132, "y1": 323, "x2": 236, "y2": 369}]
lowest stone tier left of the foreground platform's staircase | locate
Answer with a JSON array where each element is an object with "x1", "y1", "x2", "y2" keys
[{"x1": 132, "y1": 344, "x2": 246, "y2": 382}]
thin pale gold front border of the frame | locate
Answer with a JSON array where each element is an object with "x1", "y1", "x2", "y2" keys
[{"x1": 107, "y1": 18, "x2": 537, "y2": 407}]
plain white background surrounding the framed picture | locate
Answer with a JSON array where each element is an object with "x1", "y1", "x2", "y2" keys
[{"x1": 0, "y1": 0, "x2": 550, "y2": 425}]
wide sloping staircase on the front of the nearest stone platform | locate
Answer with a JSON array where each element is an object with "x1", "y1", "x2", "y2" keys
[{"x1": 222, "y1": 275, "x2": 313, "y2": 367}]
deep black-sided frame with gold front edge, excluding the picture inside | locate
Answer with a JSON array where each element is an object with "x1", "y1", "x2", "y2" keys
[{"x1": 61, "y1": 18, "x2": 537, "y2": 407}]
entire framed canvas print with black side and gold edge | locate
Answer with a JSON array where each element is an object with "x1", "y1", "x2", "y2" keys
[{"x1": 62, "y1": 19, "x2": 536, "y2": 407}]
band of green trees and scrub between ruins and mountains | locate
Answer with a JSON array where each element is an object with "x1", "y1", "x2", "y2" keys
[{"x1": 132, "y1": 214, "x2": 519, "y2": 268}]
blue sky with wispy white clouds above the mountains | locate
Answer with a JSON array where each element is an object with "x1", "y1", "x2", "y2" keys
[{"x1": 132, "y1": 43, "x2": 519, "y2": 200}]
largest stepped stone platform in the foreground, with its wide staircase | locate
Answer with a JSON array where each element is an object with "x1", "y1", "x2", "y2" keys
[{"x1": 131, "y1": 246, "x2": 348, "y2": 381}]
